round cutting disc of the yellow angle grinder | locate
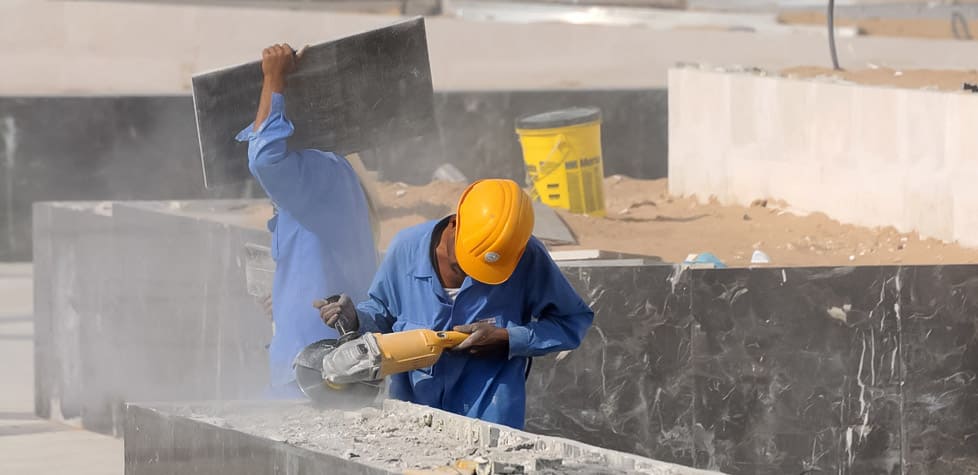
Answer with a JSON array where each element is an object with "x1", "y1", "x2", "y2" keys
[{"x1": 294, "y1": 338, "x2": 380, "y2": 406}]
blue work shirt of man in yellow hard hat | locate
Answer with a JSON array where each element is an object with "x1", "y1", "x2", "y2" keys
[{"x1": 357, "y1": 221, "x2": 594, "y2": 428}]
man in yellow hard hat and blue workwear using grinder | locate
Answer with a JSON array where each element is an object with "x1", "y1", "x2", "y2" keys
[{"x1": 320, "y1": 180, "x2": 594, "y2": 428}]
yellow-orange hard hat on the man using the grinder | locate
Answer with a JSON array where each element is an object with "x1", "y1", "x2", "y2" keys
[{"x1": 455, "y1": 179, "x2": 533, "y2": 285}]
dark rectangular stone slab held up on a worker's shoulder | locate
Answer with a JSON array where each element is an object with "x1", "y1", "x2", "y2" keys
[{"x1": 193, "y1": 18, "x2": 435, "y2": 188}]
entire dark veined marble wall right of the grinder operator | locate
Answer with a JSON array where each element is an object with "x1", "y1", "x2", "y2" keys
[{"x1": 528, "y1": 265, "x2": 978, "y2": 475}]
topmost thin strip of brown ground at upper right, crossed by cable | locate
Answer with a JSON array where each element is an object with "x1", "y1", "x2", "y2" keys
[{"x1": 778, "y1": 10, "x2": 978, "y2": 39}]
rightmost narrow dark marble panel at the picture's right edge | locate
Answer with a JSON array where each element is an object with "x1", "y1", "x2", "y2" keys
[{"x1": 900, "y1": 266, "x2": 978, "y2": 475}]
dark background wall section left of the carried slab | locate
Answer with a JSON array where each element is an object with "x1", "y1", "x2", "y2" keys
[{"x1": 0, "y1": 96, "x2": 264, "y2": 262}]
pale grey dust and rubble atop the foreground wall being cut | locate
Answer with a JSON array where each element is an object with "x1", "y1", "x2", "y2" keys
[{"x1": 184, "y1": 405, "x2": 630, "y2": 474}]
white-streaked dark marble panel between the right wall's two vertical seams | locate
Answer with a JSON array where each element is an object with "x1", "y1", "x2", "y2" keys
[{"x1": 691, "y1": 267, "x2": 901, "y2": 474}]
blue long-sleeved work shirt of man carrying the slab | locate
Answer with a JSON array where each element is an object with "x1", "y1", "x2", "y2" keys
[{"x1": 237, "y1": 94, "x2": 377, "y2": 387}]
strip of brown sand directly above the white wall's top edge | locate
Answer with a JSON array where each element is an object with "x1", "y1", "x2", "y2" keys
[{"x1": 781, "y1": 66, "x2": 978, "y2": 91}]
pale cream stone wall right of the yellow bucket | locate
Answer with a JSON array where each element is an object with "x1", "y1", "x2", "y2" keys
[{"x1": 669, "y1": 68, "x2": 978, "y2": 246}]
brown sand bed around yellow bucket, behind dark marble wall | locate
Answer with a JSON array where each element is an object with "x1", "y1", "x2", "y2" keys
[{"x1": 377, "y1": 176, "x2": 978, "y2": 266}]
